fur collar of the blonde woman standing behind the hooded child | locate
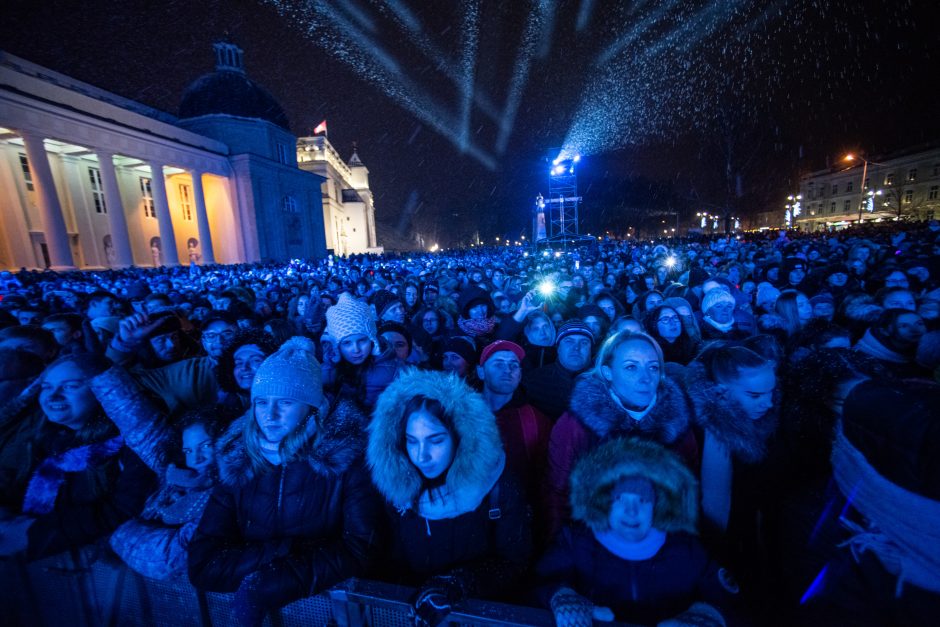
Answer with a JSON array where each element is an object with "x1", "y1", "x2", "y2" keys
[{"x1": 569, "y1": 372, "x2": 691, "y2": 445}]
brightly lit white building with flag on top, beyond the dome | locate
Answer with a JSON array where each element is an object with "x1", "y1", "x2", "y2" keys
[{"x1": 297, "y1": 135, "x2": 383, "y2": 255}]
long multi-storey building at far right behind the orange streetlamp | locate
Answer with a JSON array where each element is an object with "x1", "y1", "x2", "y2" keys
[{"x1": 792, "y1": 146, "x2": 940, "y2": 231}]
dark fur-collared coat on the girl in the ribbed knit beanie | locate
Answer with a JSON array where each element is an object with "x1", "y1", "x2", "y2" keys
[{"x1": 189, "y1": 401, "x2": 381, "y2": 607}]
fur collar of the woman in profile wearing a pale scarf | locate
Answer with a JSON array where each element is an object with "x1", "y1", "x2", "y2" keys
[{"x1": 685, "y1": 362, "x2": 780, "y2": 464}]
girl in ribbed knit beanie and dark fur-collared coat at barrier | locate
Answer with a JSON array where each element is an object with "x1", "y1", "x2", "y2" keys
[{"x1": 189, "y1": 337, "x2": 380, "y2": 625}]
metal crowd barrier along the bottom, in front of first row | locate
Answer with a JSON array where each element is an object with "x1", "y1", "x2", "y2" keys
[{"x1": 0, "y1": 547, "x2": 624, "y2": 627}]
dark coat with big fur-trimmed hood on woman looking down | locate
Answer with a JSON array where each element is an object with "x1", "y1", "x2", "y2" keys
[{"x1": 367, "y1": 370, "x2": 531, "y2": 598}]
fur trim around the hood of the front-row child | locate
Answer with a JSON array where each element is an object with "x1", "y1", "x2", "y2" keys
[{"x1": 571, "y1": 438, "x2": 698, "y2": 533}]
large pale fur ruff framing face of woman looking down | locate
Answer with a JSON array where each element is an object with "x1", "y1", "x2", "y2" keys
[{"x1": 366, "y1": 369, "x2": 505, "y2": 518}]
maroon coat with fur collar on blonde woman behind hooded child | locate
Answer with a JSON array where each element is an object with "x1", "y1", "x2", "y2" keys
[{"x1": 546, "y1": 373, "x2": 698, "y2": 531}]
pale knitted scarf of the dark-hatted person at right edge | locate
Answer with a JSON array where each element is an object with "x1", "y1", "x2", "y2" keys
[{"x1": 832, "y1": 424, "x2": 940, "y2": 596}]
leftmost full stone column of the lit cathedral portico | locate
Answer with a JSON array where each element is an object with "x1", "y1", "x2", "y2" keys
[{"x1": 20, "y1": 132, "x2": 75, "y2": 270}]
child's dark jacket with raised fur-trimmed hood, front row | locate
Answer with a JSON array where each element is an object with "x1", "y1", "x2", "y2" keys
[{"x1": 537, "y1": 438, "x2": 738, "y2": 625}]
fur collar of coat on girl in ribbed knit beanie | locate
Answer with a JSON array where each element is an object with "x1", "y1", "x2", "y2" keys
[{"x1": 215, "y1": 400, "x2": 366, "y2": 486}]
